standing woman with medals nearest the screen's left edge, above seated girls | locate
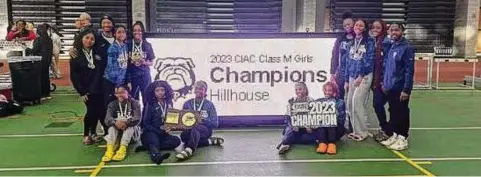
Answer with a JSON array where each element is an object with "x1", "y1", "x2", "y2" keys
[{"x1": 128, "y1": 21, "x2": 155, "y2": 105}]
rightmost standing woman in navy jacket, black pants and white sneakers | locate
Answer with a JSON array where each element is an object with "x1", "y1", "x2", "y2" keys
[{"x1": 381, "y1": 24, "x2": 415, "y2": 151}]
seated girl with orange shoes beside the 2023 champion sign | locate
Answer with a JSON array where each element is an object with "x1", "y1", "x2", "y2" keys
[{"x1": 317, "y1": 82, "x2": 346, "y2": 155}]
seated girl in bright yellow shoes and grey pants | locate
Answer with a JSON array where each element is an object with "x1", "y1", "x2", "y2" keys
[{"x1": 102, "y1": 86, "x2": 141, "y2": 162}]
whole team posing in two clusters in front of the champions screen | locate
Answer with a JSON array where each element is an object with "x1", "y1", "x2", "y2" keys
[{"x1": 63, "y1": 13, "x2": 414, "y2": 164}]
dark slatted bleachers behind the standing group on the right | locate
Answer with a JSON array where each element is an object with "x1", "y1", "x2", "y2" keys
[{"x1": 331, "y1": 0, "x2": 456, "y2": 53}]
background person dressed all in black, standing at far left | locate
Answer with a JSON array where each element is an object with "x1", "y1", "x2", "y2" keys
[{"x1": 32, "y1": 24, "x2": 53, "y2": 101}]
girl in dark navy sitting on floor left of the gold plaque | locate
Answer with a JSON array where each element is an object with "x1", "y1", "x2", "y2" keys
[{"x1": 141, "y1": 81, "x2": 183, "y2": 164}]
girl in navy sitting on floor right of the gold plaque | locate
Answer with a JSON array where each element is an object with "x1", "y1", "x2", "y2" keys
[{"x1": 175, "y1": 81, "x2": 224, "y2": 160}]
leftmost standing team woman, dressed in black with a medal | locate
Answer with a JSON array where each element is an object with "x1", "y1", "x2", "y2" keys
[{"x1": 70, "y1": 29, "x2": 105, "y2": 145}]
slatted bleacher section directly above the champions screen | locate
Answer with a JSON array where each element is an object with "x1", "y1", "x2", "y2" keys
[{"x1": 150, "y1": 0, "x2": 282, "y2": 33}]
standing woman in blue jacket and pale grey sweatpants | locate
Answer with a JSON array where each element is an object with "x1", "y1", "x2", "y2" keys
[{"x1": 344, "y1": 20, "x2": 375, "y2": 141}]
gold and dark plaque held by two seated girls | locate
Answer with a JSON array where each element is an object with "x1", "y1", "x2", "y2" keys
[{"x1": 164, "y1": 109, "x2": 201, "y2": 130}]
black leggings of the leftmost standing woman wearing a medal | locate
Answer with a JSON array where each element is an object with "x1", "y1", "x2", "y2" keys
[{"x1": 84, "y1": 95, "x2": 107, "y2": 136}]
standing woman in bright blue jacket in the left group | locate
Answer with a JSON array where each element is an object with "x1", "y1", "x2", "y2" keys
[{"x1": 103, "y1": 25, "x2": 129, "y2": 106}]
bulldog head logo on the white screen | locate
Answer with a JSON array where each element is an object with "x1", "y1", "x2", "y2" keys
[{"x1": 154, "y1": 57, "x2": 195, "y2": 101}]
